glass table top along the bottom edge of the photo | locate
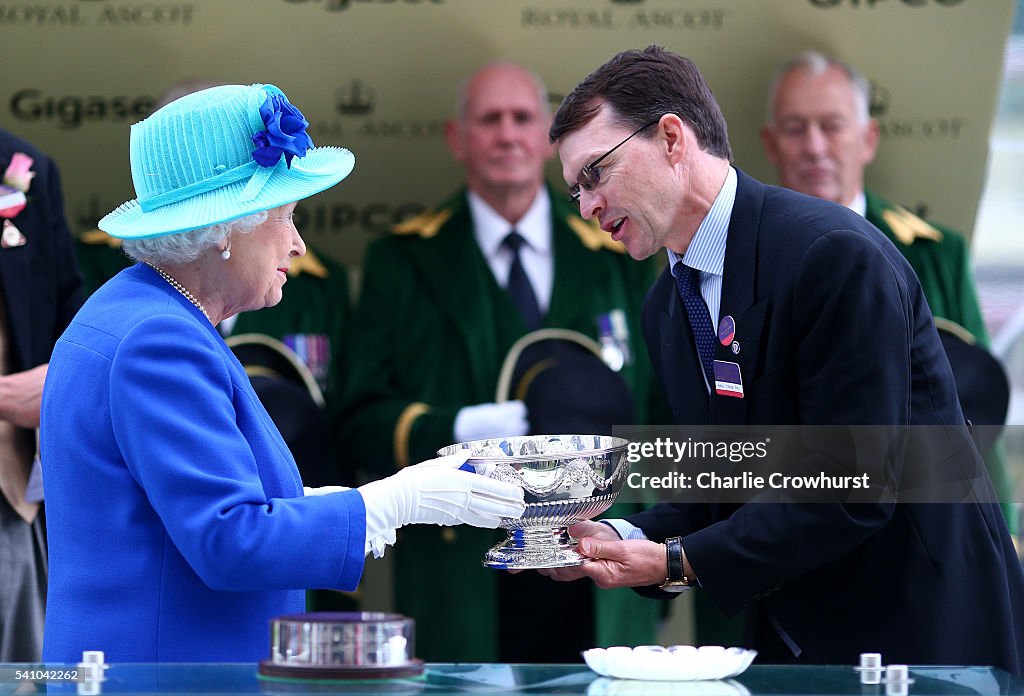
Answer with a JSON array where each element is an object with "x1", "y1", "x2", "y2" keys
[{"x1": 0, "y1": 663, "x2": 1024, "y2": 696}]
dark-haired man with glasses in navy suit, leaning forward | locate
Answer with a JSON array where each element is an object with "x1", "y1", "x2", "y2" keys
[{"x1": 542, "y1": 46, "x2": 1024, "y2": 676}]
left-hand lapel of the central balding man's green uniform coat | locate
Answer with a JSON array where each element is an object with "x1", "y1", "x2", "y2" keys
[{"x1": 410, "y1": 197, "x2": 502, "y2": 399}]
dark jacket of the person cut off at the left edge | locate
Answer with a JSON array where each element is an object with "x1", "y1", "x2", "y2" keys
[{"x1": 0, "y1": 130, "x2": 82, "y2": 373}]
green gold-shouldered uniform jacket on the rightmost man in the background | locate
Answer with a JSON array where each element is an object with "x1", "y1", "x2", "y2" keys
[{"x1": 864, "y1": 191, "x2": 1017, "y2": 534}]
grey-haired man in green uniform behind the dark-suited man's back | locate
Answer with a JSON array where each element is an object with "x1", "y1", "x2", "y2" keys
[{"x1": 761, "y1": 51, "x2": 1017, "y2": 535}]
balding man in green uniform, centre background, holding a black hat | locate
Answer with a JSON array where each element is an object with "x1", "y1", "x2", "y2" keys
[{"x1": 339, "y1": 63, "x2": 665, "y2": 662}]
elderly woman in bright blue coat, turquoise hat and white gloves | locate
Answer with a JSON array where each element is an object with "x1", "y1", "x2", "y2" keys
[{"x1": 41, "y1": 85, "x2": 524, "y2": 662}]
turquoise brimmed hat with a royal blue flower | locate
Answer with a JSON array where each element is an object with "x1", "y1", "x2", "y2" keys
[{"x1": 99, "y1": 85, "x2": 355, "y2": 240}]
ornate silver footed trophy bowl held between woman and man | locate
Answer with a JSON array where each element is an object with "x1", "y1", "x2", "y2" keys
[{"x1": 437, "y1": 435, "x2": 630, "y2": 570}]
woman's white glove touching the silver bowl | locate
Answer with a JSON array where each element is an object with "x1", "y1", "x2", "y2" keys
[{"x1": 358, "y1": 451, "x2": 526, "y2": 552}]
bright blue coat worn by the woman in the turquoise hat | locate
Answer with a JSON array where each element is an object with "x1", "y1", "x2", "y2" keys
[{"x1": 41, "y1": 264, "x2": 366, "y2": 662}]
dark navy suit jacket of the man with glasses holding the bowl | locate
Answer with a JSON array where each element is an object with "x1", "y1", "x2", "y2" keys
[{"x1": 629, "y1": 168, "x2": 1024, "y2": 675}]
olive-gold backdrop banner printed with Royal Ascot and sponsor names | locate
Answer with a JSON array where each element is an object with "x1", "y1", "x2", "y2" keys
[{"x1": 0, "y1": 0, "x2": 1014, "y2": 266}]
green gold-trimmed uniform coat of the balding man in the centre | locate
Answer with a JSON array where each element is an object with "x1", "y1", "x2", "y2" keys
[{"x1": 339, "y1": 186, "x2": 667, "y2": 662}]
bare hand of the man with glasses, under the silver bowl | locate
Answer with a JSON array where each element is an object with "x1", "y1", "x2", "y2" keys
[{"x1": 538, "y1": 522, "x2": 666, "y2": 590}]
